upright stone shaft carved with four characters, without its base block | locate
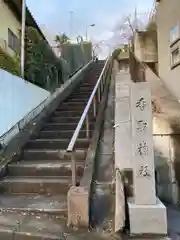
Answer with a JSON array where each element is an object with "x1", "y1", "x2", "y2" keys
[{"x1": 131, "y1": 83, "x2": 156, "y2": 204}]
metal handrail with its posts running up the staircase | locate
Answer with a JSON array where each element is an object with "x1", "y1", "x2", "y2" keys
[{"x1": 66, "y1": 57, "x2": 111, "y2": 186}]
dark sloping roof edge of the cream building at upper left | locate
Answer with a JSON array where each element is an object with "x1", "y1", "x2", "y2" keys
[{"x1": 4, "y1": 0, "x2": 47, "y2": 41}]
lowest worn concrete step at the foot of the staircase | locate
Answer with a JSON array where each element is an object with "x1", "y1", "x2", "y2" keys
[{"x1": 0, "y1": 212, "x2": 69, "y2": 240}]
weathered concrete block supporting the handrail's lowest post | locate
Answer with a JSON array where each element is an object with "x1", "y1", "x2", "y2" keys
[{"x1": 67, "y1": 187, "x2": 89, "y2": 227}]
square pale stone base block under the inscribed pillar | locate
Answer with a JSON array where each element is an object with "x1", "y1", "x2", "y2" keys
[{"x1": 128, "y1": 198, "x2": 167, "y2": 236}]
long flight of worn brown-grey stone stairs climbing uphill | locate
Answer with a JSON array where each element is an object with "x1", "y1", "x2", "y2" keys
[{"x1": 0, "y1": 61, "x2": 104, "y2": 240}]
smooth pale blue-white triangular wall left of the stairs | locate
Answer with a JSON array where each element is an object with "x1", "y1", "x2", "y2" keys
[{"x1": 0, "y1": 69, "x2": 50, "y2": 137}]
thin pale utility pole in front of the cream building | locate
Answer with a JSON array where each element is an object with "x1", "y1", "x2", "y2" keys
[{"x1": 21, "y1": 0, "x2": 26, "y2": 78}]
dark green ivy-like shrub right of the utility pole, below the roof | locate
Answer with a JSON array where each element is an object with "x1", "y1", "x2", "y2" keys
[{"x1": 25, "y1": 27, "x2": 63, "y2": 91}]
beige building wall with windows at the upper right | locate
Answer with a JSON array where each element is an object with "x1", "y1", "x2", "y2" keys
[{"x1": 156, "y1": 0, "x2": 180, "y2": 99}]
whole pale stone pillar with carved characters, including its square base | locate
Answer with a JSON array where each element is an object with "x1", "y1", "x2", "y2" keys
[{"x1": 128, "y1": 83, "x2": 167, "y2": 235}]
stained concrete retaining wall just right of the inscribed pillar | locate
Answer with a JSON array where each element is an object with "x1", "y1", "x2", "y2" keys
[{"x1": 153, "y1": 117, "x2": 180, "y2": 204}]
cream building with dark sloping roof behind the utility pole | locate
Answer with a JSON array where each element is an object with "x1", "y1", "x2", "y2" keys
[{"x1": 0, "y1": 0, "x2": 45, "y2": 57}]
